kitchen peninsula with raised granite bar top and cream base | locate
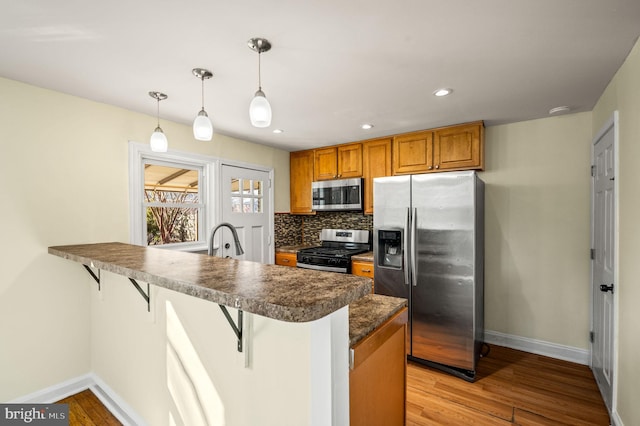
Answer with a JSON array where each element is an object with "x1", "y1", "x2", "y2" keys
[{"x1": 49, "y1": 243, "x2": 405, "y2": 425}]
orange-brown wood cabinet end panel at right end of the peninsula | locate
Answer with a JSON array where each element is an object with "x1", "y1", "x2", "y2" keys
[{"x1": 349, "y1": 308, "x2": 407, "y2": 426}]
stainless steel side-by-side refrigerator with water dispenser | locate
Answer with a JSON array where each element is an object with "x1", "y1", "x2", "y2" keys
[{"x1": 373, "y1": 171, "x2": 484, "y2": 381}]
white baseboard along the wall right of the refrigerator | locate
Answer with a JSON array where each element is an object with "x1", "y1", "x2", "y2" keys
[{"x1": 484, "y1": 330, "x2": 591, "y2": 365}]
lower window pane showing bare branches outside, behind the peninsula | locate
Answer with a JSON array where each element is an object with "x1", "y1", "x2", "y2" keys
[{"x1": 147, "y1": 207, "x2": 199, "y2": 246}]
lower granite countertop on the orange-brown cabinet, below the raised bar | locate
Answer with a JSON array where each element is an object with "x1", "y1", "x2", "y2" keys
[{"x1": 349, "y1": 294, "x2": 407, "y2": 347}]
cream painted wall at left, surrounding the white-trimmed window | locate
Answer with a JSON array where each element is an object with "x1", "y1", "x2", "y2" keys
[{"x1": 0, "y1": 78, "x2": 289, "y2": 401}]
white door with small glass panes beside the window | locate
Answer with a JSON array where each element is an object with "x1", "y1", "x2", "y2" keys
[{"x1": 219, "y1": 165, "x2": 273, "y2": 263}]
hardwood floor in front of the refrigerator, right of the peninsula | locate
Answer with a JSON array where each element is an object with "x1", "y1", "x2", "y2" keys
[{"x1": 407, "y1": 345, "x2": 609, "y2": 426}]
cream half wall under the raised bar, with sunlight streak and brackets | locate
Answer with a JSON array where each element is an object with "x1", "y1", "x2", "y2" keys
[{"x1": 88, "y1": 272, "x2": 322, "y2": 426}]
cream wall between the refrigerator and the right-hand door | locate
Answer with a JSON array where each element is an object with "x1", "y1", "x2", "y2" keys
[{"x1": 480, "y1": 113, "x2": 591, "y2": 350}]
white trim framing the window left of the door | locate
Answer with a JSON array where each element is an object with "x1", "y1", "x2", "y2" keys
[{"x1": 129, "y1": 141, "x2": 220, "y2": 251}]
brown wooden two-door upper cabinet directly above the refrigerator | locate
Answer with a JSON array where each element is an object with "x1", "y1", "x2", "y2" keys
[{"x1": 393, "y1": 121, "x2": 484, "y2": 175}]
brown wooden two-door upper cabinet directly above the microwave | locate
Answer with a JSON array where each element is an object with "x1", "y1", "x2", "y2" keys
[{"x1": 313, "y1": 142, "x2": 362, "y2": 180}]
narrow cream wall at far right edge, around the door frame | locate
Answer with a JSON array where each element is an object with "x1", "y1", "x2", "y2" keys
[{"x1": 592, "y1": 37, "x2": 640, "y2": 425}]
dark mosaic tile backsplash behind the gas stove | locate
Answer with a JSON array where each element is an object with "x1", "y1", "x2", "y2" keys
[{"x1": 274, "y1": 212, "x2": 373, "y2": 248}]
